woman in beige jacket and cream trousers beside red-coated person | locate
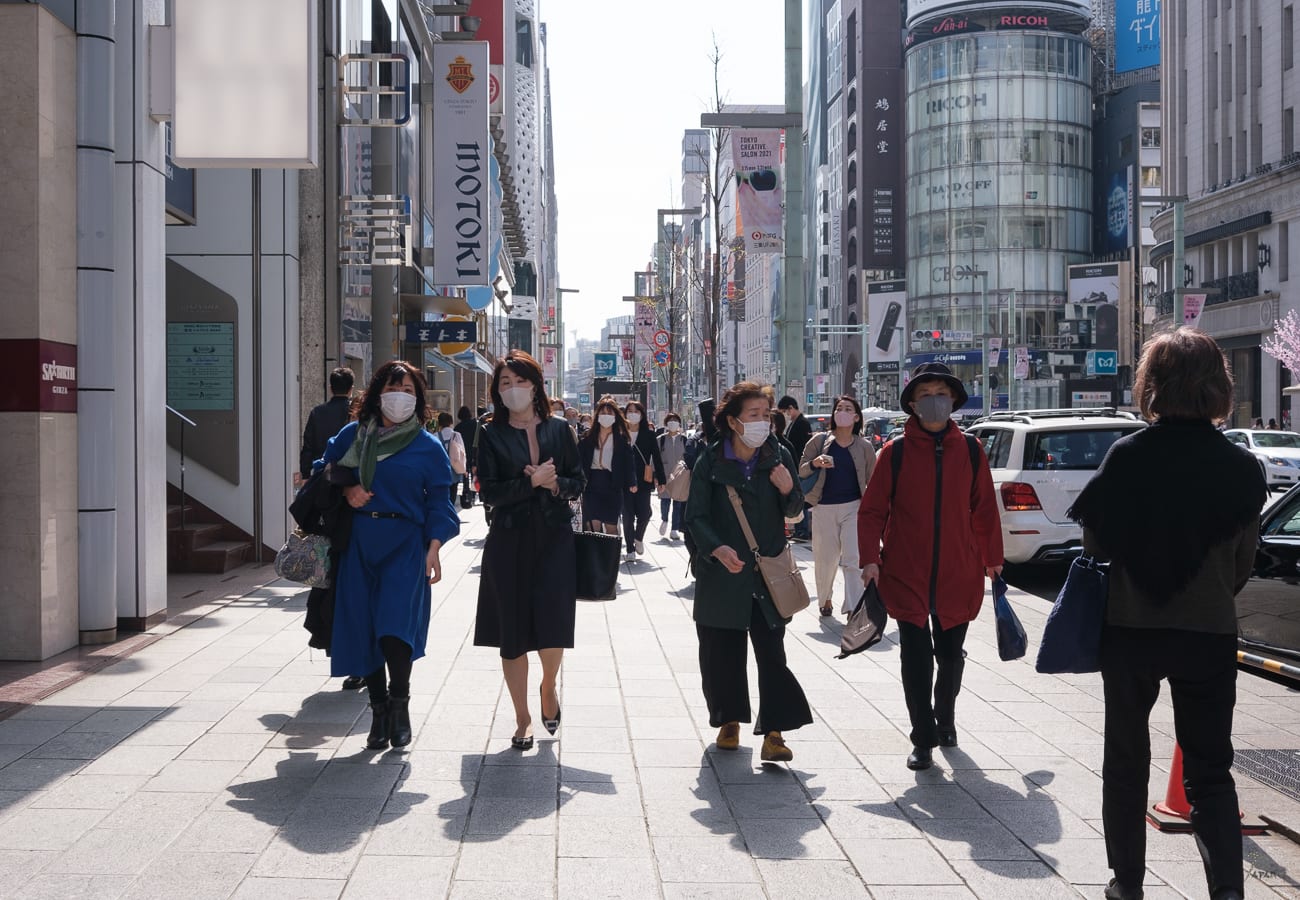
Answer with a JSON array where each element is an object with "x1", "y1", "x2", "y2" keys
[{"x1": 800, "y1": 397, "x2": 876, "y2": 615}]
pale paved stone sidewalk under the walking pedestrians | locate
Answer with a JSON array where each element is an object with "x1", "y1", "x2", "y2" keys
[{"x1": 0, "y1": 510, "x2": 1300, "y2": 900}]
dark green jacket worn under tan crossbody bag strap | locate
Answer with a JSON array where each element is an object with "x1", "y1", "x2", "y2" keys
[{"x1": 685, "y1": 437, "x2": 803, "y2": 631}]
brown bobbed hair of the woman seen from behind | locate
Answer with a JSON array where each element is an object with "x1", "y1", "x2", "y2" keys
[{"x1": 1134, "y1": 328, "x2": 1232, "y2": 421}]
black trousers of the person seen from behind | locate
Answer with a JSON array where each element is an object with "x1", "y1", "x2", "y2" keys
[{"x1": 1101, "y1": 626, "x2": 1243, "y2": 896}]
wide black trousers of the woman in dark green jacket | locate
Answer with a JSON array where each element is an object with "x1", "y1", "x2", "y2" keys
[{"x1": 696, "y1": 600, "x2": 813, "y2": 735}]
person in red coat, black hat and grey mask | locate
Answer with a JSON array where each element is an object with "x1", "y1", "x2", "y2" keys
[{"x1": 858, "y1": 363, "x2": 1002, "y2": 770}]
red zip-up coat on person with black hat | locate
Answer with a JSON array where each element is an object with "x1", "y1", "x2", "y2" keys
[{"x1": 858, "y1": 416, "x2": 1002, "y2": 629}]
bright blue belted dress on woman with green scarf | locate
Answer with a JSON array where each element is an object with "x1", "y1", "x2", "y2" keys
[{"x1": 324, "y1": 423, "x2": 460, "y2": 675}]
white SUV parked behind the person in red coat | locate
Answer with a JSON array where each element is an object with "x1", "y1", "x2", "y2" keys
[{"x1": 966, "y1": 408, "x2": 1145, "y2": 563}]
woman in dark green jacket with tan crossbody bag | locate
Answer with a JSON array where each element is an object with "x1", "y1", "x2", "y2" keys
[{"x1": 686, "y1": 381, "x2": 813, "y2": 762}]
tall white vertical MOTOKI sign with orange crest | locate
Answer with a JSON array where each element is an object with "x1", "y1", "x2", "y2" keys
[{"x1": 432, "y1": 40, "x2": 491, "y2": 285}]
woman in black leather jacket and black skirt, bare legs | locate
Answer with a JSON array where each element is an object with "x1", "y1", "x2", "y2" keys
[{"x1": 475, "y1": 350, "x2": 586, "y2": 750}]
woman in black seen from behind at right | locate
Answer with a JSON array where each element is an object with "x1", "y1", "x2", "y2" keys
[{"x1": 1069, "y1": 328, "x2": 1268, "y2": 900}]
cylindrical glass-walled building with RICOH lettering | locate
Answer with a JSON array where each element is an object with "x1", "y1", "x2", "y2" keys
[{"x1": 906, "y1": 8, "x2": 1092, "y2": 407}]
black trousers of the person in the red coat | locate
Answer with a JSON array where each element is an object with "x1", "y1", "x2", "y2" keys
[{"x1": 898, "y1": 616, "x2": 970, "y2": 747}]
